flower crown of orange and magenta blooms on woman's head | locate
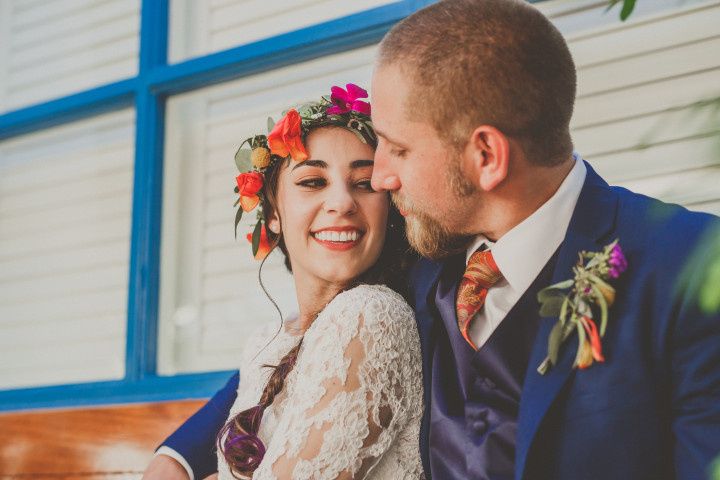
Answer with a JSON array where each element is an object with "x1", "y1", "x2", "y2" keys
[{"x1": 234, "y1": 83, "x2": 377, "y2": 260}]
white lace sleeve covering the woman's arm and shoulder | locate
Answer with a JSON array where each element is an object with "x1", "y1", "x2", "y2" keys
[{"x1": 253, "y1": 285, "x2": 420, "y2": 480}]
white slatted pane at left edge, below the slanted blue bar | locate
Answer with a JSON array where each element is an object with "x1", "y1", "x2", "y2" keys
[{"x1": 0, "y1": 111, "x2": 134, "y2": 389}]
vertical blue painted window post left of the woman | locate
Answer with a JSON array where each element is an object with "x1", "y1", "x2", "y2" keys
[{"x1": 125, "y1": 0, "x2": 168, "y2": 381}]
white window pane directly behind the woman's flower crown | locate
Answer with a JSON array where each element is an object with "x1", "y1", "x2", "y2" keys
[{"x1": 158, "y1": 47, "x2": 374, "y2": 374}]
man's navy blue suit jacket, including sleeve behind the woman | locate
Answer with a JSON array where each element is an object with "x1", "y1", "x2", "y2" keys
[{"x1": 165, "y1": 165, "x2": 720, "y2": 480}]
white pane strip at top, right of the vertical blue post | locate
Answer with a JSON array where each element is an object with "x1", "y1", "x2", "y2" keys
[{"x1": 169, "y1": 0, "x2": 397, "y2": 62}]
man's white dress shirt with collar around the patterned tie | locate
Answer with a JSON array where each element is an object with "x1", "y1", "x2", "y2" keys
[{"x1": 465, "y1": 154, "x2": 587, "y2": 348}]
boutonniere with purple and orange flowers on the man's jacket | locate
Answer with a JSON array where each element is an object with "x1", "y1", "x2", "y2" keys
[{"x1": 537, "y1": 240, "x2": 627, "y2": 375}]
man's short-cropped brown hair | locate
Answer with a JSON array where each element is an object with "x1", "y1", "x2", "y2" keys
[{"x1": 378, "y1": 0, "x2": 576, "y2": 165}]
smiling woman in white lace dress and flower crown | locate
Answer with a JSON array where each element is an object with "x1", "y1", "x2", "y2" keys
[{"x1": 218, "y1": 84, "x2": 423, "y2": 480}]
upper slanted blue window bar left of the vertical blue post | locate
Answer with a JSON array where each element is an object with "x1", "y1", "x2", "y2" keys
[{"x1": 0, "y1": 78, "x2": 138, "y2": 140}]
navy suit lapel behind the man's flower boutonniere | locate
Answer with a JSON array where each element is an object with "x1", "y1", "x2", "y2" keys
[{"x1": 515, "y1": 163, "x2": 617, "y2": 480}]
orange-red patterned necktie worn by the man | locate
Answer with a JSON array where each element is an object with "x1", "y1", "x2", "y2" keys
[{"x1": 455, "y1": 250, "x2": 502, "y2": 350}]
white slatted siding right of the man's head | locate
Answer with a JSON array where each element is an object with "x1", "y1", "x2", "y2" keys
[{"x1": 538, "y1": 0, "x2": 720, "y2": 214}]
